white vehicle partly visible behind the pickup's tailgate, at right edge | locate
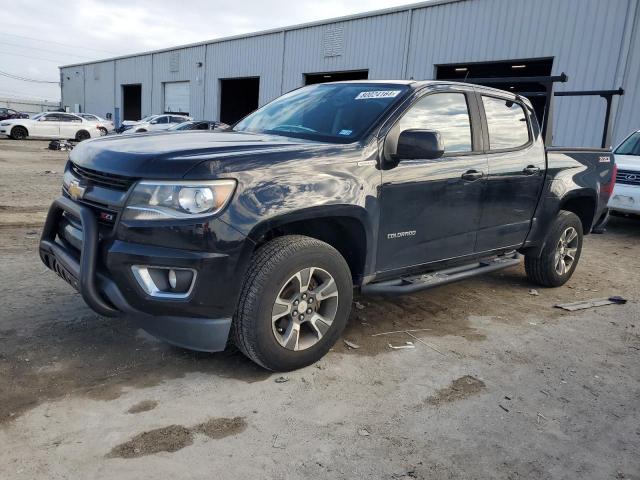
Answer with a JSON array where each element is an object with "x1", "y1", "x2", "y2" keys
[{"x1": 609, "y1": 130, "x2": 640, "y2": 215}]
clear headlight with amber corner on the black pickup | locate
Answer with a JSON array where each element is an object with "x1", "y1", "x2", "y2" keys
[{"x1": 122, "y1": 180, "x2": 236, "y2": 220}]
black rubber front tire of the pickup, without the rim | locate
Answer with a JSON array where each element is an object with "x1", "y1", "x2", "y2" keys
[{"x1": 231, "y1": 235, "x2": 353, "y2": 371}]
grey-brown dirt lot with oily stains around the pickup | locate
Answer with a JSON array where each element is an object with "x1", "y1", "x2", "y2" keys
[{"x1": 0, "y1": 140, "x2": 640, "y2": 479}]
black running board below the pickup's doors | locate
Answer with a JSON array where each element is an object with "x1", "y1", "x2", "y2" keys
[{"x1": 360, "y1": 253, "x2": 520, "y2": 295}]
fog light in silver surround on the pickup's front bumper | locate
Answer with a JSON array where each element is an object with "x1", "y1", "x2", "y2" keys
[{"x1": 131, "y1": 265, "x2": 196, "y2": 298}]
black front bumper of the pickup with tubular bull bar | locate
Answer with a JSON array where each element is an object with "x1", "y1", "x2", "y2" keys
[{"x1": 39, "y1": 197, "x2": 234, "y2": 352}]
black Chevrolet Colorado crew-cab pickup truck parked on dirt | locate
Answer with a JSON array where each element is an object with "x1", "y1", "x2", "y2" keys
[{"x1": 40, "y1": 81, "x2": 615, "y2": 370}]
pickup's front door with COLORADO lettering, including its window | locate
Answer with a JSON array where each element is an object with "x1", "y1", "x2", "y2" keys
[{"x1": 377, "y1": 91, "x2": 488, "y2": 271}]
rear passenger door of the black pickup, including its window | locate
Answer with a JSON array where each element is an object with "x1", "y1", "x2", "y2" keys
[{"x1": 476, "y1": 93, "x2": 546, "y2": 252}]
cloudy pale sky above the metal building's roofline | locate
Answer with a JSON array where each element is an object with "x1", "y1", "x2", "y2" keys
[{"x1": 0, "y1": 0, "x2": 415, "y2": 101}]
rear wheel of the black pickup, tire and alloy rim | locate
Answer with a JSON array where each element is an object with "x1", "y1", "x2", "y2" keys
[{"x1": 524, "y1": 210, "x2": 583, "y2": 287}]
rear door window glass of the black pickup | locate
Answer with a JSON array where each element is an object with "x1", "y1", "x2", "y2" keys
[{"x1": 482, "y1": 96, "x2": 529, "y2": 150}]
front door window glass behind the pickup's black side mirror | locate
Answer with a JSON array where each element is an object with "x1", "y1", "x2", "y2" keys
[{"x1": 396, "y1": 93, "x2": 472, "y2": 153}]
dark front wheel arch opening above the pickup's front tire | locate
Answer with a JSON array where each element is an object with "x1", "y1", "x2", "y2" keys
[{"x1": 249, "y1": 205, "x2": 375, "y2": 285}]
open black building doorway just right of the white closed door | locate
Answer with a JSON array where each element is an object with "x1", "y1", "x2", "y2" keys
[{"x1": 220, "y1": 77, "x2": 260, "y2": 125}]
